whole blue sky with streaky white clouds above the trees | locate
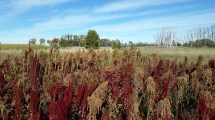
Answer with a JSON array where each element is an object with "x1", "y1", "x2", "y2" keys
[{"x1": 0, "y1": 0, "x2": 215, "y2": 43}]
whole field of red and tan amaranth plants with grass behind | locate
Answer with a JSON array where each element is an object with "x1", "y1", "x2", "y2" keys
[{"x1": 0, "y1": 47, "x2": 215, "y2": 120}]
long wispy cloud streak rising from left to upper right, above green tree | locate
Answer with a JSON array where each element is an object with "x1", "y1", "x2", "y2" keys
[{"x1": 7, "y1": 7, "x2": 186, "y2": 34}]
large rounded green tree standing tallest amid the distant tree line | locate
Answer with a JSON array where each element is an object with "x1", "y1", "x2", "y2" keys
[{"x1": 85, "y1": 30, "x2": 100, "y2": 49}]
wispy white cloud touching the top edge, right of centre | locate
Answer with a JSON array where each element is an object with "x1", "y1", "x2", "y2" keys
[{"x1": 95, "y1": 0, "x2": 191, "y2": 13}]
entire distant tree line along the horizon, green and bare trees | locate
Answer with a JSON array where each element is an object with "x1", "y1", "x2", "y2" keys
[{"x1": 29, "y1": 25, "x2": 215, "y2": 49}]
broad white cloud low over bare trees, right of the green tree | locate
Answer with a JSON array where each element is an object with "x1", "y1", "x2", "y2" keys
[{"x1": 93, "y1": 12, "x2": 215, "y2": 42}]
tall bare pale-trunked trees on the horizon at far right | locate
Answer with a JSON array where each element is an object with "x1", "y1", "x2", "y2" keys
[{"x1": 154, "y1": 25, "x2": 215, "y2": 47}]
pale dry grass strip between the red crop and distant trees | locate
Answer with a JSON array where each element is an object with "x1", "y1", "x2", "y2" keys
[{"x1": 0, "y1": 44, "x2": 215, "y2": 63}]
